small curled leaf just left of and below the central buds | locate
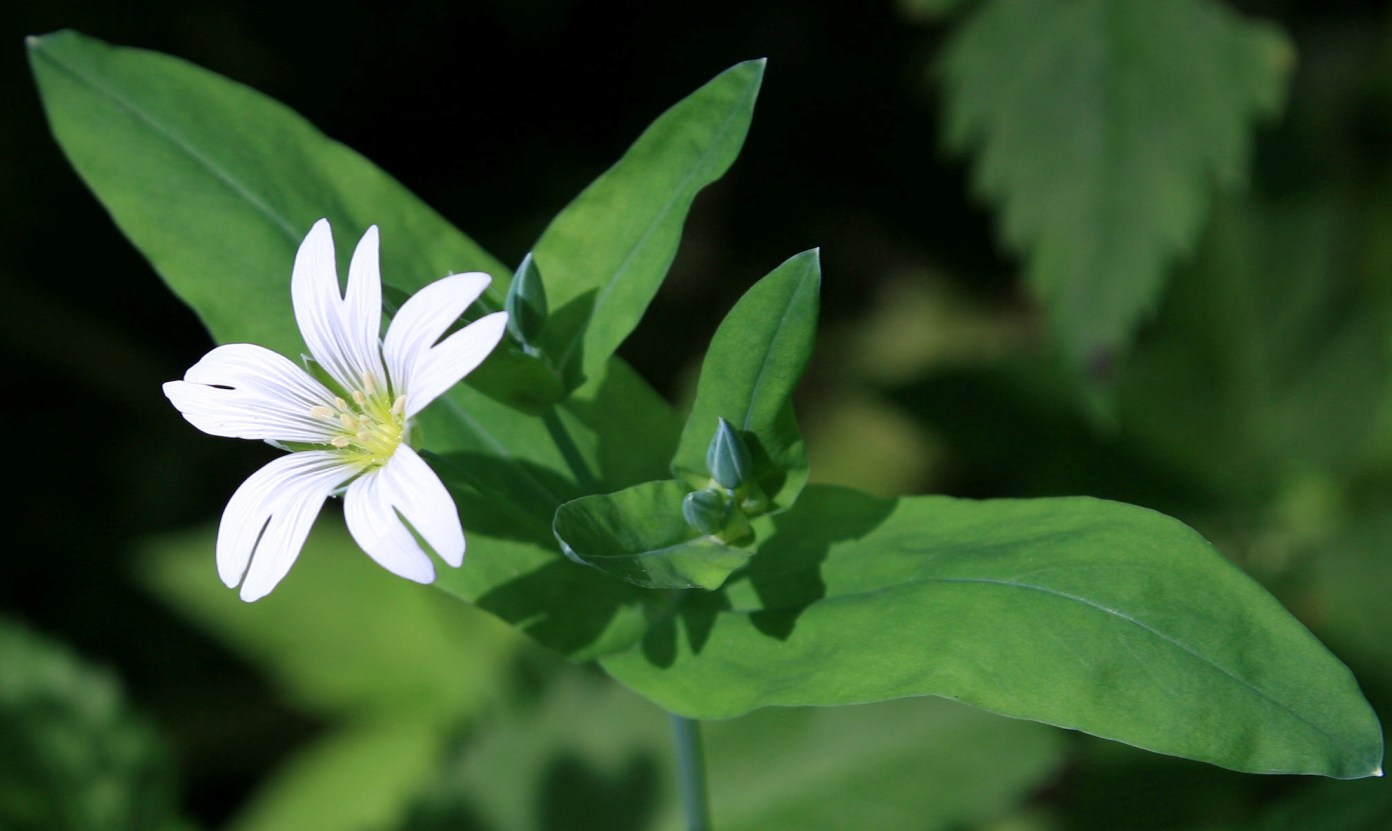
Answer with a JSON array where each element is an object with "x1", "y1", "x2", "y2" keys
[{"x1": 553, "y1": 479, "x2": 753, "y2": 589}]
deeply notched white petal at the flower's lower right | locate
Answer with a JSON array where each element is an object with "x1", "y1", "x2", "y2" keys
[{"x1": 344, "y1": 445, "x2": 464, "y2": 583}]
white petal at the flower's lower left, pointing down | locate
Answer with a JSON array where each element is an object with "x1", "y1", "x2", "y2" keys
[{"x1": 217, "y1": 451, "x2": 354, "y2": 603}]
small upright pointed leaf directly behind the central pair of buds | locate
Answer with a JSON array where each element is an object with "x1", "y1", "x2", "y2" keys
[{"x1": 672, "y1": 251, "x2": 821, "y2": 508}]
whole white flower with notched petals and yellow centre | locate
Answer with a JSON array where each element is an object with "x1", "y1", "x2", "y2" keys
[{"x1": 164, "y1": 220, "x2": 507, "y2": 601}]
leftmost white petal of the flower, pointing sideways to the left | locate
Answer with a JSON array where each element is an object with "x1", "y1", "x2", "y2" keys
[{"x1": 164, "y1": 344, "x2": 334, "y2": 443}]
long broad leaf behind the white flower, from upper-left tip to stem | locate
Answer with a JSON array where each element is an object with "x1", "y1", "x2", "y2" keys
[{"x1": 29, "y1": 32, "x2": 679, "y2": 656}]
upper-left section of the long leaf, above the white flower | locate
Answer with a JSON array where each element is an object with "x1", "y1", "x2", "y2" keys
[{"x1": 29, "y1": 32, "x2": 509, "y2": 355}]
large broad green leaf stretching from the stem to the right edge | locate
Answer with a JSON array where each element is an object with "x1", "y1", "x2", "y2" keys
[{"x1": 603, "y1": 487, "x2": 1382, "y2": 778}]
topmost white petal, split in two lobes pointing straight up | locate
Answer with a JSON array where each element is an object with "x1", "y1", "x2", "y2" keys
[{"x1": 290, "y1": 220, "x2": 383, "y2": 390}]
